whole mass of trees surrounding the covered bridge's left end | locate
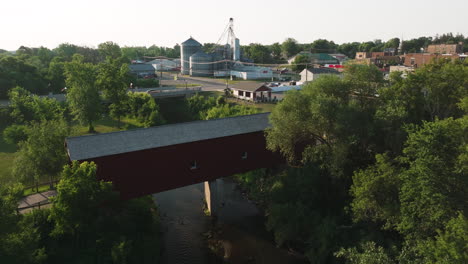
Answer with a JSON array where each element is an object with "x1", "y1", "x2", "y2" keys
[{"x1": 0, "y1": 48, "x2": 172, "y2": 263}]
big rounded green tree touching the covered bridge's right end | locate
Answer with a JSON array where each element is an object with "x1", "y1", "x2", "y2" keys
[{"x1": 266, "y1": 71, "x2": 376, "y2": 172}]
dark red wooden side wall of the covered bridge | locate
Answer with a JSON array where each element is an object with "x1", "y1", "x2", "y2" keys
[{"x1": 84, "y1": 131, "x2": 282, "y2": 199}]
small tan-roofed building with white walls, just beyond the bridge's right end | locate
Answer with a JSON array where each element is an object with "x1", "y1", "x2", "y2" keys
[{"x1": 230, "y1": 82, "x2": 272, "y2": 102}]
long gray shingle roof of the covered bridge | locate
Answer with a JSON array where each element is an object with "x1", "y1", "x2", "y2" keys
[{"x1": 65, "y1": 113, "x2": 270, "y2": 160}]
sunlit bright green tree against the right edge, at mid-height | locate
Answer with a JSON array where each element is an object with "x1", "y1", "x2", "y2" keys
[{"x1": 398, "y1": 118, "x2": 468, "y2": 238}]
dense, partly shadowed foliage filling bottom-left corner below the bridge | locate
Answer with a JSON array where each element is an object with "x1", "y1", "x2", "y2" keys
[{"x1": 0, "y1": 162, "x2": 160, "y2": 264}]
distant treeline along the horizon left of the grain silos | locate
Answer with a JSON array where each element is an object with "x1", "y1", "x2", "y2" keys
[{"x1": 0, "y1": 42, "x2": 180, "y2": 99}]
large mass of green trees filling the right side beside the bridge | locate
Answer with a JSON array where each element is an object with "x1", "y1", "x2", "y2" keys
[{"x1": 237, "y1": 60, "x2": 468, "y2": 264}]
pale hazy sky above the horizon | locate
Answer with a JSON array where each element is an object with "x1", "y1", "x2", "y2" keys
[{"x1": 0, "y1": 0, "x2": 468, "y2": 50}]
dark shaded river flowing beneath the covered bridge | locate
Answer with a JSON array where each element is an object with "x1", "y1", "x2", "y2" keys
[{"x1": 153, "y1": 178, "x2": 304, "y2": 264}]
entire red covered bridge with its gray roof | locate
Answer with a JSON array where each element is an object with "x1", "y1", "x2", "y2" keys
[{"x1": 66, "y1": 113, "x2": 282, "y2": 199}]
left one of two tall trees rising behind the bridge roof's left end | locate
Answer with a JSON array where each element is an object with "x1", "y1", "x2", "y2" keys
[{"x1": 65, "y1": 55, "x2": 101, "y2": 133}]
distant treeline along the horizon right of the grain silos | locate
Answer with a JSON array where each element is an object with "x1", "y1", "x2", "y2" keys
[{"x1": 236, "y1": 33, "x2": 468, "y2": 63}]
